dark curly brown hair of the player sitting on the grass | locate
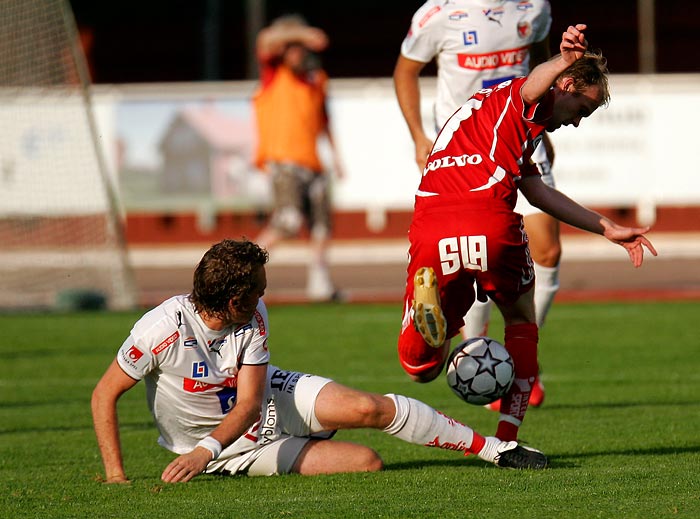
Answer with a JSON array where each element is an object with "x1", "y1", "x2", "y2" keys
[{"x1": 190, "y1": 240, "x2": 269, "y2": 319}]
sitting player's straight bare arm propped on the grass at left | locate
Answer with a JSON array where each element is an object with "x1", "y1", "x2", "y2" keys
[{"x1": 91, "y1": 360, "x2": 138, "y2": 483}]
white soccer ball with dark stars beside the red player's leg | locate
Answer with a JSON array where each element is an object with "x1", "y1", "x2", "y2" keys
[{"x1": 447, "y1": 337, "x2": 515, "y2": 405}]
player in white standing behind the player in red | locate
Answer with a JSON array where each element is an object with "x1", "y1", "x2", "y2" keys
[{"x1": 394, "y1": 0, "x2": 561, "y2": 409}]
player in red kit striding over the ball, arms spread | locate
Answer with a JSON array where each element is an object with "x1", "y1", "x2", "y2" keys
[{"x1": 398, "y1": 24, "x2": 656, "y2": 448}]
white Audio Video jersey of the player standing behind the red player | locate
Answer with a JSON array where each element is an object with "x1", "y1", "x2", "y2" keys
[{"x1": 401, "y1": 0, "x2": 552, "y2": 130}]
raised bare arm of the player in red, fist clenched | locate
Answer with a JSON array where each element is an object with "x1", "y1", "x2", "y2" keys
[{"x1": 520, "y1": 24, "x2": 588, "y2": 105}]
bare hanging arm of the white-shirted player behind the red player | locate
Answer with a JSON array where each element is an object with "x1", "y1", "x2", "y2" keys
[{"x1": 394, "y1": 55, "x2": 433, "y2": 171}]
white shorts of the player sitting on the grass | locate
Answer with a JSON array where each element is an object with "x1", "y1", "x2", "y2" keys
[{"x1": 206, "y1": 366, "x2": 335, "y2": 476}]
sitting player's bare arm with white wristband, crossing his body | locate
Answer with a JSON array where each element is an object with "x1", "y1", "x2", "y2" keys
[{"x1": 161, "y1": 364, "x2": 267, "y2": 483}]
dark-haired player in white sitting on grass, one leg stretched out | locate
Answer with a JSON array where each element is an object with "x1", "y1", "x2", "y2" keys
[{"x1": 92, "y1": 240, "x2": 547, "y2": 483}]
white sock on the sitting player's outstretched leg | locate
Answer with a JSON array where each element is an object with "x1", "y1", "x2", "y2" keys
[{"x1": 384, "y1": 394, "x2": 474, "y2": 451}]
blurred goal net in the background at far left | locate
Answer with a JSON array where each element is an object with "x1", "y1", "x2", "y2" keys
[{"x1": 0, "y1": 0, "x2": 135, "y2": 310}]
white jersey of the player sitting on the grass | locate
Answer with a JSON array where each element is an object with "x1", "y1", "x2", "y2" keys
[{"x1": 117, "y1": 295, "x2": 270, "y2": 454}]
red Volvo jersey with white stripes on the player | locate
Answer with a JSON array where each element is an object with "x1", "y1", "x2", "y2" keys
[{"x1": 416, "y1": 77, "x2": 553, "y2": 209}]
